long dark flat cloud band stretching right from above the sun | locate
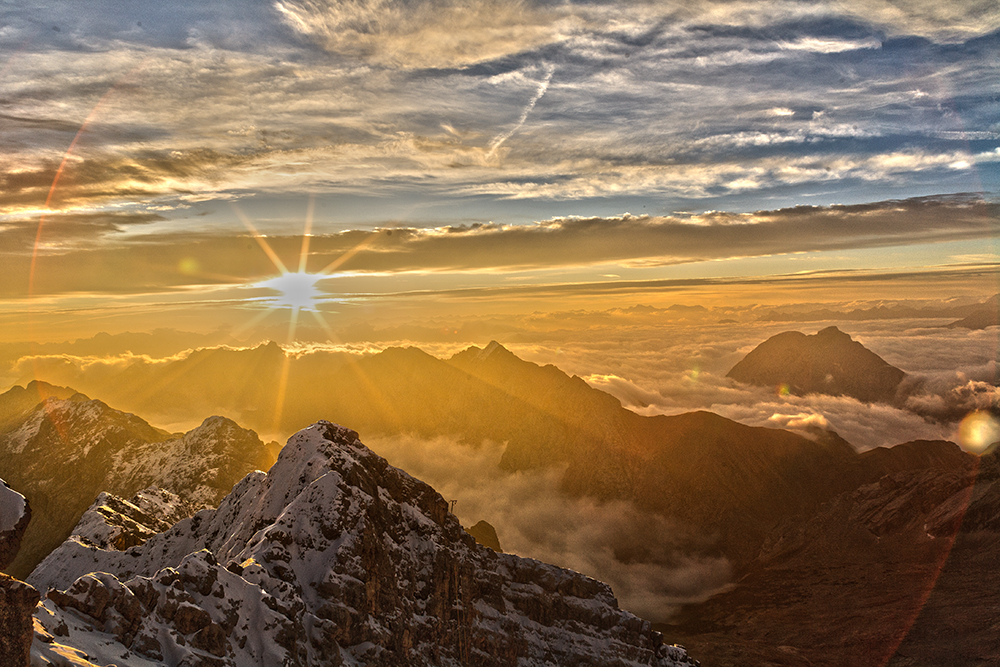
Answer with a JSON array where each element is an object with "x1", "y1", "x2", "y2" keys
[{"x1": 227, "y1": 198, "x2": 1000, "y2": 272}]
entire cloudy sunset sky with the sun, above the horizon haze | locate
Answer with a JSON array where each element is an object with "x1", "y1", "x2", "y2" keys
[{"x1": 0, "y1": 0, "x2": 1000, "y2": 340}]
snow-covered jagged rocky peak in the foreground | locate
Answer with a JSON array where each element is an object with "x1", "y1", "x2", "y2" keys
[{"x1": 32, "y1": 422, "x2": 695, "y2": 667}]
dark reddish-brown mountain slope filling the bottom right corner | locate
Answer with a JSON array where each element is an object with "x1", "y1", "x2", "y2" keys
[{"x1": 657, "y1": 441, "x2": 1000, "y2": 667}]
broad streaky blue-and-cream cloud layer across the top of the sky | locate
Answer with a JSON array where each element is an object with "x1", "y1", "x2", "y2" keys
[{"x1": 0, "y1": 0, "x2": 1000, "y2": 224}]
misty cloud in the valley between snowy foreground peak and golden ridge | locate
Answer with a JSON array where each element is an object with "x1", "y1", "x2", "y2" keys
[{"x1": 364, "y1": 437, "x2": 732, "y2": 621}]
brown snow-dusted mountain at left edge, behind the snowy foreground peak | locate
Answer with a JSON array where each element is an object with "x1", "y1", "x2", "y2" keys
[{"x1": 0, "y1": 383, "x2": 274, "y2": 578}]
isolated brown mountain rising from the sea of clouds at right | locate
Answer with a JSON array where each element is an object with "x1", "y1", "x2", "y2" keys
[{"x1": 727, "y1": 327, "x2": 906, "y2": 403}]
